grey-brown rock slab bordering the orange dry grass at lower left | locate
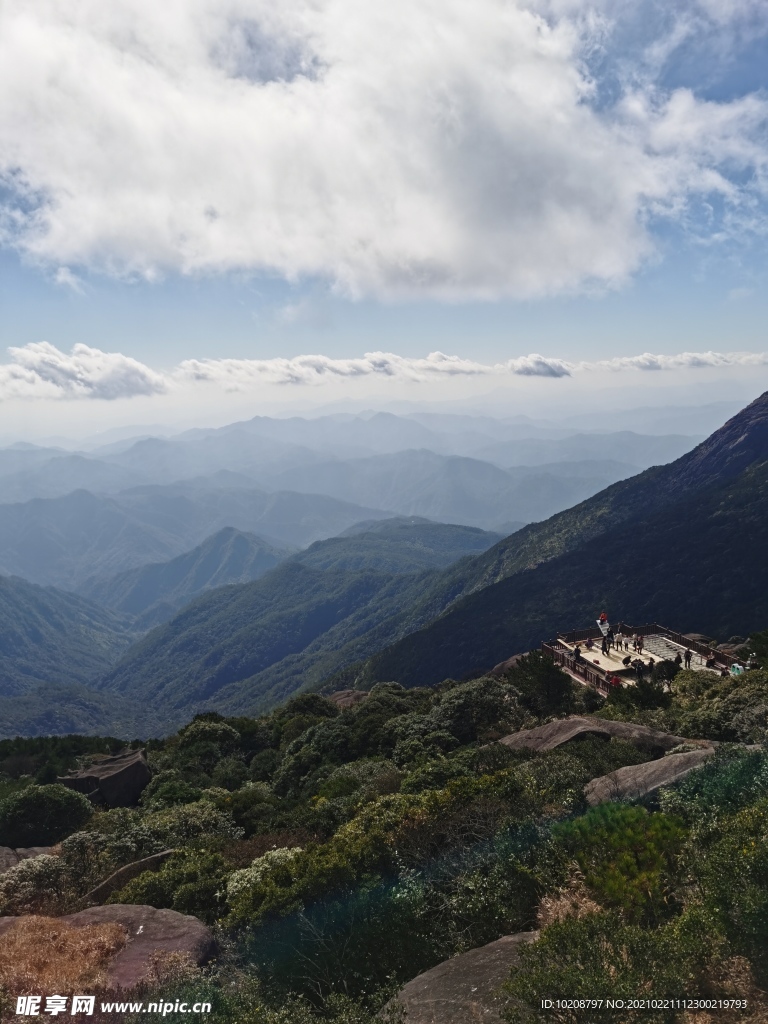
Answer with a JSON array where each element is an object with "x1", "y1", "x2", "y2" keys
[{"x1": 0, "y1": 903, "x2": 216, "y2": 990}]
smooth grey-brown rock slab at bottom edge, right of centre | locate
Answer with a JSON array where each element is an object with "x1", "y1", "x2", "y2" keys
[{"x1": 392, "y1": 932, "x2": 539, "y2": 1024}]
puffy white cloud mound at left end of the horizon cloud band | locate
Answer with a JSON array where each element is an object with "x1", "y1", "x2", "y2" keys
[{"x1": 0, "y1": 341, "x2": 168, "y2": 399}]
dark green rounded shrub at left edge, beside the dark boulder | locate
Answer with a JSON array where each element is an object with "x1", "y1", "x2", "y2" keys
[{"x1": 0, "y1": 783, "x2": 93, "y2": 848}]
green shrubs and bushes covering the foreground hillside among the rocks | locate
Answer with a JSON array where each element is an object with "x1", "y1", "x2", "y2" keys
[{"x1": 0, "y1": 638, "x2": 768, "y2": 1024}]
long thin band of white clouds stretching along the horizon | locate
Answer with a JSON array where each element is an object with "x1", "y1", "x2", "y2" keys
[{"x1": 0, "y1": 342, "x2": 768, "y2": 401}]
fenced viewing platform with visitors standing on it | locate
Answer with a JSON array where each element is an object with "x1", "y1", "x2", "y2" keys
[{"x1": 542, "y1": 623, "x2": 738, "y2": 694}]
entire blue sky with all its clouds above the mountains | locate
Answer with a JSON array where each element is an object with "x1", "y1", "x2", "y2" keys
[{"x1": 0, "y1": 0, "x2": 768, "y2": 436}]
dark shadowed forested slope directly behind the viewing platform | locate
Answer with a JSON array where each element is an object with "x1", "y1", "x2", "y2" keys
[{"x1": 360, "y1": 452, "x2": 768, "y2": 686}]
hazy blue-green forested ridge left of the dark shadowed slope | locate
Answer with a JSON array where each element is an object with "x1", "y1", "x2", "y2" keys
[{"x1": 99, "y1": 519, "x2": 495, "y2": 724}]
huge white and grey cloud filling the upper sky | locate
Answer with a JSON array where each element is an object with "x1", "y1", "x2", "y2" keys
[{"x1": 0, "y1": 0, "x2": 768, "y2": 299}]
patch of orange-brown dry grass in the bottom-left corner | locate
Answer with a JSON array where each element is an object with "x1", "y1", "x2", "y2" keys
[{"x1": 0, "y1": 916, "x2": 127, "y2": 995}]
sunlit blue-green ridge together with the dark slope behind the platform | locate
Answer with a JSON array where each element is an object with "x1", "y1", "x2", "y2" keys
[{"x1": 94, "y1": 385, "x2": 768, "y2": 729}]
